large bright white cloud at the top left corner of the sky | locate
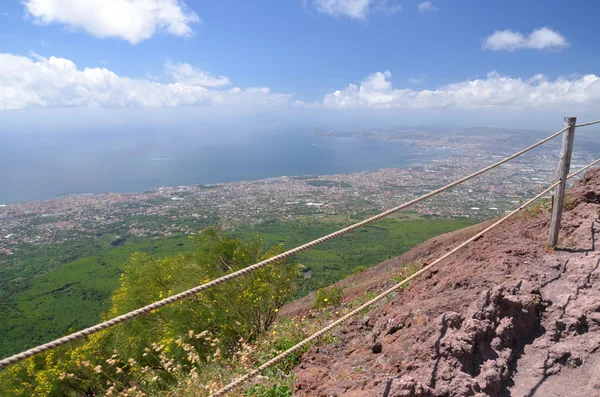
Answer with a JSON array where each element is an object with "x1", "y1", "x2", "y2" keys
[{"x1": 23, "y1": 0, "x2": 200, "y2": 44}]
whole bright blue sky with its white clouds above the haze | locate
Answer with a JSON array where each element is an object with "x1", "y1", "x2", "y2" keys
[{"x1": 0, "y1": 0, "x2": 600, "y2": 126}]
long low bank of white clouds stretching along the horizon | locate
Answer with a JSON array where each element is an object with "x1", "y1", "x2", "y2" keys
[{"x1": 5, "y1": 52, "x2": 600, "y2": 111}]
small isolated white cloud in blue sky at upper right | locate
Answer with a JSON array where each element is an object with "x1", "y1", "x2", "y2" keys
[{"x1": 483, "y1": 27, "x2": 569, "y2": 51}]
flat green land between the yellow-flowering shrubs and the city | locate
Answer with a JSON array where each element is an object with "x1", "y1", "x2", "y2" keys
[{"x1": 0, "y1": 213, "x2": 473, "y2": 356}]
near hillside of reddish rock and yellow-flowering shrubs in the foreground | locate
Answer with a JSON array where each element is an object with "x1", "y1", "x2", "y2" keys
[{"x1": 0, "y1": 170, "x2": 600, "y2": 397}]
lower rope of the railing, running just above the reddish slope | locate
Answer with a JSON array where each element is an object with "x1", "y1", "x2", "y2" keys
[{"x1": 210, "y1": 159, "x2": 600, "y2": 397}]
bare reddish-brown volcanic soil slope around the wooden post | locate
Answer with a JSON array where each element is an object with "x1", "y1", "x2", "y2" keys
[{"x1": 284, "y1": 169, "x2": 600, "y2": 397}]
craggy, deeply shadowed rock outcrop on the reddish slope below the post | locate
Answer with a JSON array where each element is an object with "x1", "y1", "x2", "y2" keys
[{"x1": 430, "y1": 287, "x2": 544, "y2": 396}]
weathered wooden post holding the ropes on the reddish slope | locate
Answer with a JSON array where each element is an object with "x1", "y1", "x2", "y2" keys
[{"x1": 548, "y1": 117, "x2": 577, "y2": 248}]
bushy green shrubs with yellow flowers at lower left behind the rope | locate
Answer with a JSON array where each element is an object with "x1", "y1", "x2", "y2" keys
[{"x1": 0, "y1": 229, "x2": 297, "y2": 397}]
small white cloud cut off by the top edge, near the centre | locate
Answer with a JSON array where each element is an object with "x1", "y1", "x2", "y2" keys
[{"x1": 313, "y1": 0, "x2": 402, "y2": 20}]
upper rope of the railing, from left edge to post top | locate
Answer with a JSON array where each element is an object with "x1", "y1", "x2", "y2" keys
[{"x1": 0, "y1": 126, "x2": 569, "y2": 370}]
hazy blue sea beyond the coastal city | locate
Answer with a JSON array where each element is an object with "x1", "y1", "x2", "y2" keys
[{"x1": 0, "y1": 128, "x2": 450, "y2": 205}]
